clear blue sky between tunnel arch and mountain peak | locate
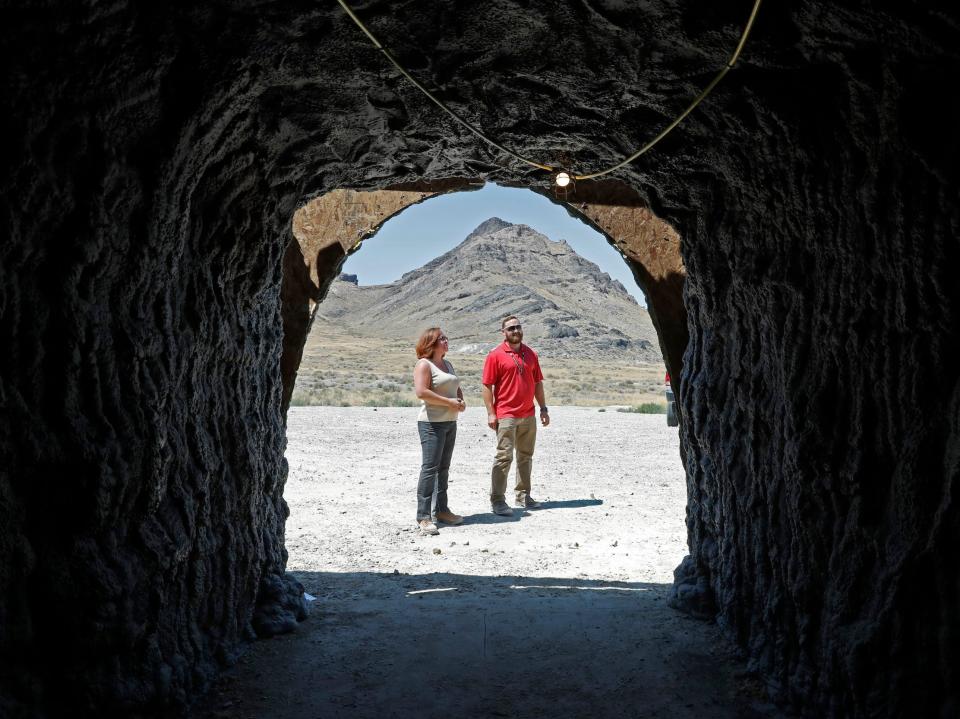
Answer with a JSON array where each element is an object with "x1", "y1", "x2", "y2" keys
[{"x1": 343, "y1": 184, "x2": 646, "y2": 307}]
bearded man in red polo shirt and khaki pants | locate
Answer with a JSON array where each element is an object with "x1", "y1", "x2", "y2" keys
[{"x1": 481, "y1": 315, "x2": 550, "y2": 517}]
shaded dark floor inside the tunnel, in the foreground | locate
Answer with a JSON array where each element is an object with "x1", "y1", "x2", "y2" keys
[{"x1": 193, "y1": 572, "x2": 776, "y2": 719}]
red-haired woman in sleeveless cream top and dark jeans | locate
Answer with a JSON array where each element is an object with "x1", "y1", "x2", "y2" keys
[{"x1": 413, "y1": 327, "x2": 467, "y2": 535}]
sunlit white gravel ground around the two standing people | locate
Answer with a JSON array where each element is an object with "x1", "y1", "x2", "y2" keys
[{"x1": 284, "y1": 407, "x2": 686, "y2": 583}]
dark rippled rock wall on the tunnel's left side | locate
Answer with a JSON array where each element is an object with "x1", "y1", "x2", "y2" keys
[{"x1": 0, "y1": 3, "x2": 295, "y2": 716}]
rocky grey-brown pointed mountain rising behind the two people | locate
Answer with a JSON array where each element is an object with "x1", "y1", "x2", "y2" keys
[{"x1": 308, "y1": 217, "x2": 662, "y2": 363}]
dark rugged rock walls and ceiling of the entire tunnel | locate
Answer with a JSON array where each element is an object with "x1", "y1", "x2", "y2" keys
[{"x1": 0, "y1": 0, "x2": 960, "y2": 716}]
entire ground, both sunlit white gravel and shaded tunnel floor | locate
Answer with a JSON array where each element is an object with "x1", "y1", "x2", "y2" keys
[{"x1": 195, "y1": 404, "x2": 778, "y2": 719}]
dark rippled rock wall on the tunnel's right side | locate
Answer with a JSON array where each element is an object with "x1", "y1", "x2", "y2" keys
[{"x1": 680, "y1": 7, "x2": 960, "y2": 717}]
